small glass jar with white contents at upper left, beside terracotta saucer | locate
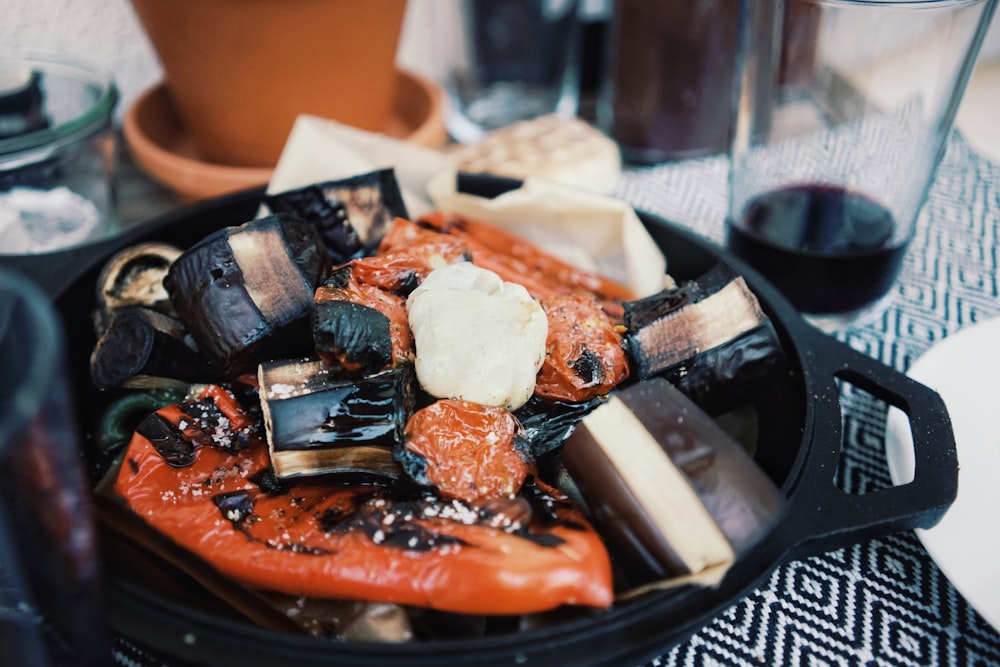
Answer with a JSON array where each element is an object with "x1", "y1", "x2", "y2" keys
[{"x1": 0, "y1": 55, "x2": 119, "y2": 255}]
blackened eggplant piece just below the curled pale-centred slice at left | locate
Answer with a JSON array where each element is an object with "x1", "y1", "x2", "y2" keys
[{"x1": 90, "y1": 306, "x2": 219, "y2": 390}]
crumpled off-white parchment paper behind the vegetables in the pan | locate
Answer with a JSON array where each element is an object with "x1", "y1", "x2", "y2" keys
[{"x1": 270, "y1": 115, "x2": 666, "y2": 296}]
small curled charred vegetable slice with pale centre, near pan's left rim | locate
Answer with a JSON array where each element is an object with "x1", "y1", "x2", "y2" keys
[{"x1": 95, "y1": 243, "x2": 181, "y2": 334}]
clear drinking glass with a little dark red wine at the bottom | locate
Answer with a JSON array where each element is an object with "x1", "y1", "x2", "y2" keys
[{"x1": 726, "y1": 0, "x2": 997, "y2": 331}]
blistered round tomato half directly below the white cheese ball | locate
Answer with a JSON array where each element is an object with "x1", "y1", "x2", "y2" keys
[{"x1": 396, "y1": 399, "x2": 534, "y2": 504}]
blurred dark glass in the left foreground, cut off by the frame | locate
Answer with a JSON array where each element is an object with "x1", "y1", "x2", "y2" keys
[{"x1": 0, "y1": 268, "x2": 111, "y2": 667}]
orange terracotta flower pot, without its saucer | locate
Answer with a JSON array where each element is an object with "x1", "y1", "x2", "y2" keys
[{"x1": 132, "y1": 0, "x2": 406, "y2": 167}]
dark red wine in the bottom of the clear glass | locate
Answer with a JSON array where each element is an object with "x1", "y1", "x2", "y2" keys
[{"x1": 726, "y1": 185, "x2": 907, "y2": 315}]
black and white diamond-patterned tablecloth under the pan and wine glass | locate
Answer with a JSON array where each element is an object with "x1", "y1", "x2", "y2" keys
[{"x1": 617, "y1": 132, "x2": 1000, "y2": 667}]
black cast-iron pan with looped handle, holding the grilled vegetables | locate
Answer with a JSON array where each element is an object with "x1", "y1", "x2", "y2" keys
[{"x1": 3, "y1": 184, "x2": 958, "y2": 667}]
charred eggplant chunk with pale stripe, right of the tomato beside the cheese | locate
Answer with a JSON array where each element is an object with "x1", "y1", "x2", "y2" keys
[{"x1": 625, "y1": 264, "x2": 784, "y2": 413}]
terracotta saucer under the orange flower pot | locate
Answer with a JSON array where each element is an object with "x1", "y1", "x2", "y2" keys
[{"x1": 122, "y1": 70, "x2": 448, "y2": 201}]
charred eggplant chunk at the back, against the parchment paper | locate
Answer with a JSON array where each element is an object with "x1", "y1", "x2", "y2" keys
[{"x1": 264, "y1": 169, "x2": 409, "y2": 264}]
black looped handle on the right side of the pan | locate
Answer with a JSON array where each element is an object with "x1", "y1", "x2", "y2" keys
[{"x1": 776, "y1": 326, "x2": 958, "y2": 558}]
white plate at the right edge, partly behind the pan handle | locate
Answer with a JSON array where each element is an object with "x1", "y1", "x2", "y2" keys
[{"x1": 886, "y1": 318, "x2": 1000, "y2": 629}]
